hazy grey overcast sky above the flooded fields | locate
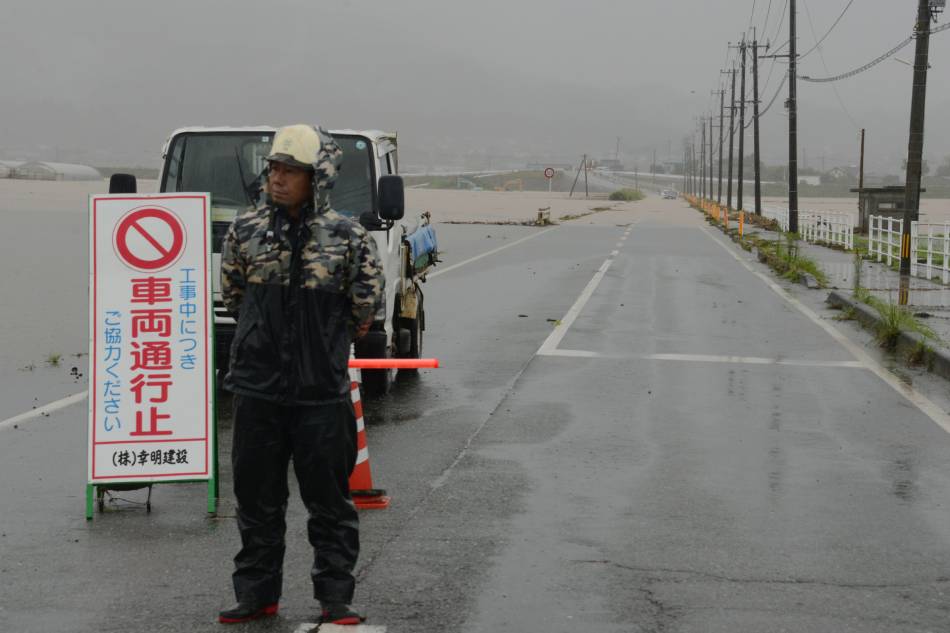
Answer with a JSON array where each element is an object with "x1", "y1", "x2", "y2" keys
[{"x1": 0, "y1": 0, "x2": 950, "y2": 172}]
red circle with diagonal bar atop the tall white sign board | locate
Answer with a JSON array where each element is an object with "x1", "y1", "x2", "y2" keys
[{"x1": 112, "y1": 207, "x2": 185, "y2": 273}]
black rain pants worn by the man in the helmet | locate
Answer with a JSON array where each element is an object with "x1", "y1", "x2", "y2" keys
[{"x1": 231, "y1": 395, "x2": 360, "y2": 604}]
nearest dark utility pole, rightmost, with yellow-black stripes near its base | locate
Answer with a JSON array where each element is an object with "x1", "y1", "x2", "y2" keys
[{"x1": 900, "y1": 0, "x2": 940, "y2": 286}]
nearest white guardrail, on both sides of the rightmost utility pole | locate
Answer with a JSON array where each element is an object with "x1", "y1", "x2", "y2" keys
[{"x1": 868, "y1": 215, "x2": 950, "y2": 284}]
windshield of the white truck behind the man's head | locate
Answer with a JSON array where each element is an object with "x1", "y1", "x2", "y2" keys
[{"x1": 161, "y1": 132, "x2": 376, "y2": 253}]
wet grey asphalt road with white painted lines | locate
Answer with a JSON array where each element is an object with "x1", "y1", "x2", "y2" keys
[{"x1": 0, "y1": 198, "x2": 950, "y2": 633}]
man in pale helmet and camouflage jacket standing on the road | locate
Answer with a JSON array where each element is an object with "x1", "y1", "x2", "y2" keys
[{"x1": 218, "y1": 125, "x2": 384, "y2": 624}]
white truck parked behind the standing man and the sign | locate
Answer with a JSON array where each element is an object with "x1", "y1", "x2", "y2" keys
[{"x1": 109, "y1": 127, "x2": 438, "y2": 395}]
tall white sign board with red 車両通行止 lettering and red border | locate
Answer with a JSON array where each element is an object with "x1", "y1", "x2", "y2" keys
[{"x1": 88, "y1": 194, "x2": 214, "y2": 483}]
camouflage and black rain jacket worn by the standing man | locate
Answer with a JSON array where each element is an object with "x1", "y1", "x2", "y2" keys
[{"x1": 221, "y1": 206, "x2": 385, "y2": 404}]
